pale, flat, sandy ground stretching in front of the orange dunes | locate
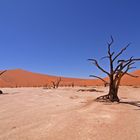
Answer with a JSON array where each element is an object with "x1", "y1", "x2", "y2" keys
[{"x1": 0, "y1": 87, "x2": 140, "y2": 140}]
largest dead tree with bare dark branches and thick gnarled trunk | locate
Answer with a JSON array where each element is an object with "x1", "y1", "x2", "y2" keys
[{"x1": 89, "y1": 36, "x2": 140, "y2": 102}]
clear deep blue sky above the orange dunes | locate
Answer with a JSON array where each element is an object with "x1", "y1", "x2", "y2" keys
[{"x1": 0, "y1": 0, "x2": 140, "y2": 78}]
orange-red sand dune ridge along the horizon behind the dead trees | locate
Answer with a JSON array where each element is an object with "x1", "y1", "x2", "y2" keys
[{"x1": 0, "y1": 69, "x2": 140, "y2": 87}]
